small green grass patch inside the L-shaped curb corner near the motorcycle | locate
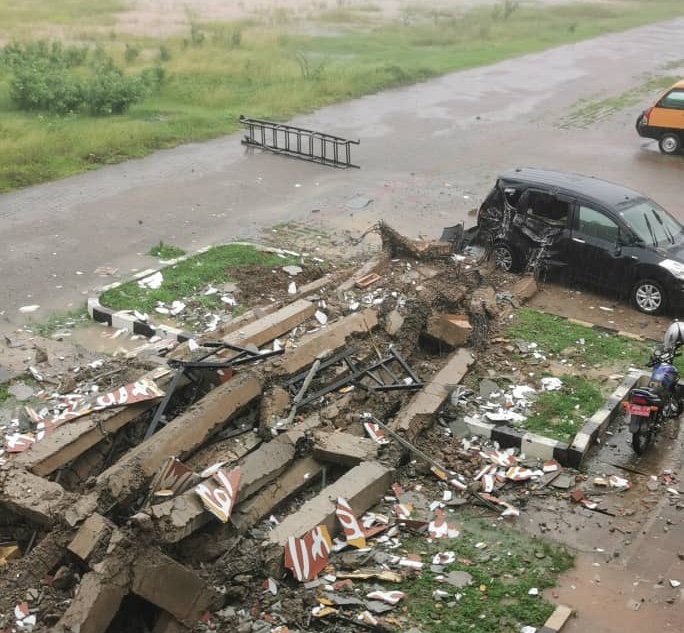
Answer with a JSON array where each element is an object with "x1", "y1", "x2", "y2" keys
[{"x1": 520, "y1": 375, "x2": 606, "y2": 442}]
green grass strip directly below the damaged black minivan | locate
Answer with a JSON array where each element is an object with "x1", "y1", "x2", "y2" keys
[{"x1": 502, "y1": 308, "x2": 652, "y2": 369}]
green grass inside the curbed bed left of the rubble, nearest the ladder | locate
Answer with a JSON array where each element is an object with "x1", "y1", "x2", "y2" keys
[{"x1": 100, "y1": 244, "x2": 295, "y2": 312}]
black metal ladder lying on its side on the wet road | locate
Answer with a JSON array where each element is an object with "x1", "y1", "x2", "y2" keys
[{"x1": 240, "y1": 115, "x2": 359, "y2": 169}]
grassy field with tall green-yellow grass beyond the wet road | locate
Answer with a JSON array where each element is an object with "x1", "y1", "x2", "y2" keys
[{"x1": 0, "y1": 0, "x2": 684, "y2": 191}]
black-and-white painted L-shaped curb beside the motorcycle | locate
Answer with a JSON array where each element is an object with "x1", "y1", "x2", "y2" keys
[{"x1": 466, "y1": 370, "x2": 648, "y2": 468}]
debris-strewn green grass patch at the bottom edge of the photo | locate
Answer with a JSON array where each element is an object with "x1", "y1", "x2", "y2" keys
[{"x1": 396, "y1": 516, "x2": 573, "y2": 633}]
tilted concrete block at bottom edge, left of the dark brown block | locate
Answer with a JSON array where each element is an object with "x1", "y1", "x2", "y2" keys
[{"x1": 54, "y1": 572, "x2": 128, "y2": 633}]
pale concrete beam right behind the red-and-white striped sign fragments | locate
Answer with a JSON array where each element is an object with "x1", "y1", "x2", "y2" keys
[{"x1": 269, "y1": 462, "x2": 394, "y2": 546}]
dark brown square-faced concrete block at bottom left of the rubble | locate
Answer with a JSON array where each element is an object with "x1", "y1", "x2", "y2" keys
[{"x1": 130, "y1": 549, "x2": 215, "y2": 630}]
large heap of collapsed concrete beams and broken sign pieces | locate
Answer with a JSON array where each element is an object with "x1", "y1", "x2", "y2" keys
[{"x1": 0, "y1": 224, "x2": 616, "y2": 633}]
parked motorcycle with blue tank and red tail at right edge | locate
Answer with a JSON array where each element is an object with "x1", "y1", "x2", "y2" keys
[{"x1": 624, "y1": 347, "x2": 683, "y2": 455}]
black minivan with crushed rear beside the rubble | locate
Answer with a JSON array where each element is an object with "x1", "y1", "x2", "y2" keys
[{"x1": 477, "y1": 168, "x2": 684, "y2": 314}]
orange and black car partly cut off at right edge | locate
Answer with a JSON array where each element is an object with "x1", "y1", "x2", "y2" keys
[{"x1": 636, "y1": 80, "x2": 684, "y2": 154}]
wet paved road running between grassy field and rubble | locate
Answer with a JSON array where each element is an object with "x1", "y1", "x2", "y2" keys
[{"x1": 0, "y1": 19, "x2": 684, "y2": 329}]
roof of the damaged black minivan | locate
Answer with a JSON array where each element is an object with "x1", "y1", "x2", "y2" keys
[{"x1": 500, "y1": 167, "x2": 644, "y2": 205}]
